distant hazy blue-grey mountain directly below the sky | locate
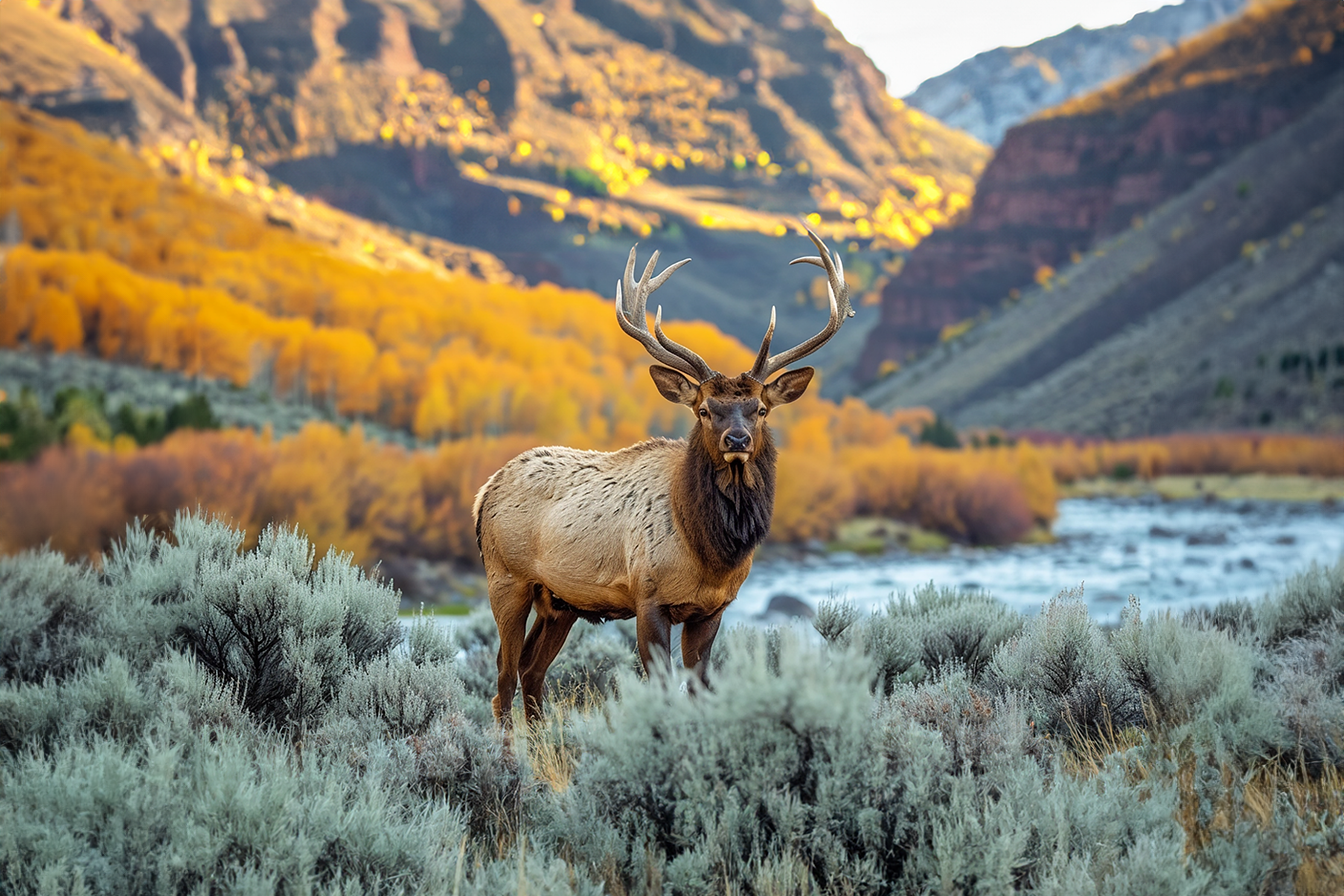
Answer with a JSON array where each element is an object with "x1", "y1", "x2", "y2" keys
[{"x1": 905, "y1": 0, "x2": 1247, "y2": 146}]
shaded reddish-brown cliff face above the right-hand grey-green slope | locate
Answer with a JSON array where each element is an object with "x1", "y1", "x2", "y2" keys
[{"x1": 856, "y1": 3, "x2": 1344, "y2": 382}]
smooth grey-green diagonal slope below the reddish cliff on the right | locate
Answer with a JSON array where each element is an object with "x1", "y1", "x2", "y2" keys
[{"x1": 866, "y1": 78, "x2": 1344, "y2": 438}]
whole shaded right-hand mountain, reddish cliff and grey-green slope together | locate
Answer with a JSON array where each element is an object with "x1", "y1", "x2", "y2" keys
[{"x1": 862, "y1": 3, "x2": 1344, "y2": 437}]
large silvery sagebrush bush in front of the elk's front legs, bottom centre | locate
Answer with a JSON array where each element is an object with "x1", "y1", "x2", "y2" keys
[{"x1": 550, "y1": 630, "x2": 934, "y2": 893}]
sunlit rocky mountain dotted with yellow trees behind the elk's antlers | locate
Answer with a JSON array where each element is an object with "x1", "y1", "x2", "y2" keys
[{"x1": 0, "y1": 0, "x2": 988, "y2": 360}]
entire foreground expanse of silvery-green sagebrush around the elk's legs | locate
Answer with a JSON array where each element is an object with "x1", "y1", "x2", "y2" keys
[{"x1": 0, "y1": 514, "x2": 1344, "y2": 896}]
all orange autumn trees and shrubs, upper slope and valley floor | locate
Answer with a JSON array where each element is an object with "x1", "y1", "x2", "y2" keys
[{"x1": 0, "y1": 103, "x2": 1340, "y2": 562}]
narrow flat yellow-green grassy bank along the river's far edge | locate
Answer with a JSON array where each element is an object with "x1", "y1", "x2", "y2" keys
[{"x1": 1059, "y1": 473, "x2": 1344, "y2": 502}]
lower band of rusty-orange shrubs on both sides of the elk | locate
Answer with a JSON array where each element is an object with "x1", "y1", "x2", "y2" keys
[{"x1": 0, "y1": 411, "x2": 1055, "y2": 562}]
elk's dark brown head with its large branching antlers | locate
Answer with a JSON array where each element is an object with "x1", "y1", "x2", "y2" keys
[{"x1": 616, "y1": 228, "x2": 853, "y2": 486}]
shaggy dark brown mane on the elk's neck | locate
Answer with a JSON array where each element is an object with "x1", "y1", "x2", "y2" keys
[{"x1": 672, "y1": 427, "x2": 777, "y2": 574}]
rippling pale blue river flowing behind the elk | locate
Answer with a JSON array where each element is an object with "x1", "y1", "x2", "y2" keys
[{"x1": 724, "y1": 497, "x2": 1344, "y2": 623}]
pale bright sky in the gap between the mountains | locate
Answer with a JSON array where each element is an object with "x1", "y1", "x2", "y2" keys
[{"x1": 814, "y1": 0, "x2": 1172, "y2": 97}]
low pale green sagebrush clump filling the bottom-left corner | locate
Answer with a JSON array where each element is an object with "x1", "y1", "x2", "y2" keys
[{"x1": 0, "y1": 735, "x2": 466, "y2": 896}]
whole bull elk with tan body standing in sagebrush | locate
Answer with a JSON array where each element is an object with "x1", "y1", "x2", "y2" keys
[{"x1": 472, "y1": 228, "x2": 853, "y2": 727}]
